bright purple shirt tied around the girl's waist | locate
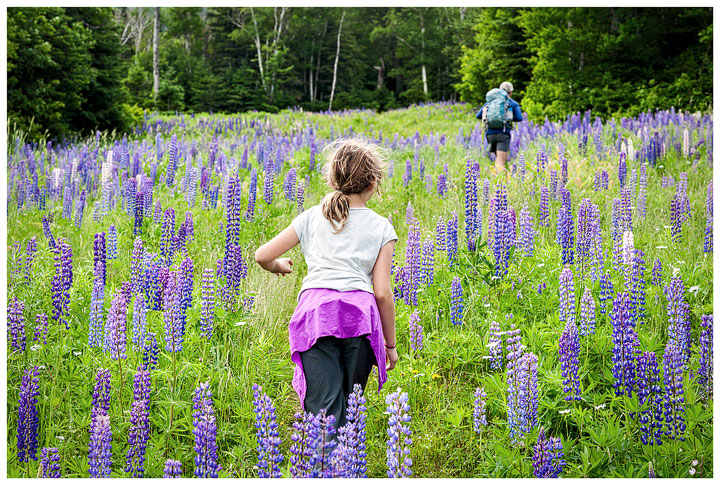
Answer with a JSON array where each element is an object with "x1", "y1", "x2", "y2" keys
[{"x1": 289, "y1": 288, "x2": 387, "y2": 409}]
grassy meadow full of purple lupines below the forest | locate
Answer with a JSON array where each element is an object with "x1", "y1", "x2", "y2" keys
[{"x1": 7, "y1": 103, "x2": 713, "y2": 478}]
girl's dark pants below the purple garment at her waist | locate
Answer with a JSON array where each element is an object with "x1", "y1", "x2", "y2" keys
[{"x1": 300, "y1": 337, "x2": 376, "y2": 429}]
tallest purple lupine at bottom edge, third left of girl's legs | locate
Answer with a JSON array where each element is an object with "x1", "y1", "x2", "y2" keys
[{"x1": 125, "y1": 364, "x2": 150, "y2": 478}]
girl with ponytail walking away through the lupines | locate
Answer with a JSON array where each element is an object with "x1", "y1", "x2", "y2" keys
[{"x1": 255, "y1": 140, "x2": 398, "y2": 429}]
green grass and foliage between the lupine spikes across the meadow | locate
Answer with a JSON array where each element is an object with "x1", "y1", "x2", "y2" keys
[{"x1": 7, "y1": 105, "x2": 713, "y2": 477}]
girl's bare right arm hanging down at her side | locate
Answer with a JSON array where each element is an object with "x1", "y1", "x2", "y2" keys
[{"x1": 373, "y1": 241, "x2": 398, "y2": 370}]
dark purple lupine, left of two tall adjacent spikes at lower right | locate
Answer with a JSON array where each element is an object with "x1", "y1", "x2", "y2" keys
[{"x1": 637, "y1": 351, "x2": 663, "y2": 445}]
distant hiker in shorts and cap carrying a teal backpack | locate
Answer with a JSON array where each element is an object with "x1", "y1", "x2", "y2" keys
[{"x1": 475, "y1": 81, "x2": 522, "y2": 175}]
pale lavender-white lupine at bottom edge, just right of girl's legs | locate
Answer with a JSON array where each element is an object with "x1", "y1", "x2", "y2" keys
[{"x1": 385, "y1": 387, "x2": 412, "y2": 478}]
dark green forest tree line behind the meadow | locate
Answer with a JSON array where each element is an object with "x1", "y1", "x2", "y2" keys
[{"x1": 7, "y1": 7, "x2": 712, "y2": 137}]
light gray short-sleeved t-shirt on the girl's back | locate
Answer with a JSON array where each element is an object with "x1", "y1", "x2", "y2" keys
[{"x1": 292, "y1": 205, "x2": 398, "y2": 298}]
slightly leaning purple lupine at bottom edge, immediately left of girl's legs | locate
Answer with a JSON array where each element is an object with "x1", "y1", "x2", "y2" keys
[{"x1": 253, "y1": 384, "x2": 283, "y2": 478}]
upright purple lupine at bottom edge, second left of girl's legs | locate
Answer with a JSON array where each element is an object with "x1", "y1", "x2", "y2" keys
[{"x1": 193, "y1": 382, "x2": 220, "y2": 478}]
